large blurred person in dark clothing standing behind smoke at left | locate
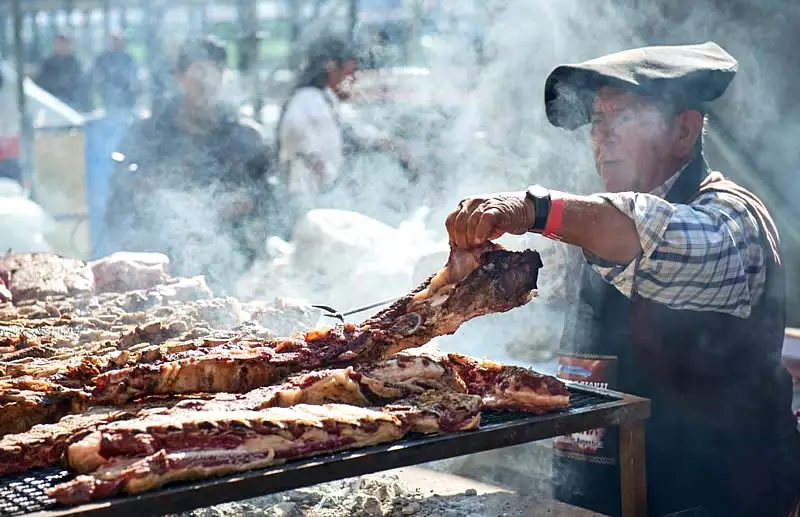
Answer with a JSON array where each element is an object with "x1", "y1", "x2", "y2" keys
[{"x1": 104, "y1": 38, "x2": 275, "y2": 293}]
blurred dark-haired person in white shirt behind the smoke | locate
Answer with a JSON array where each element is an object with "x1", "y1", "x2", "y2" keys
[{"x1": 277, "y1": 35, "x2": 411, "y2": 222}]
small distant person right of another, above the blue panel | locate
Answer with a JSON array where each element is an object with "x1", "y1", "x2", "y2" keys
[{"x1": 91, "y1": 33, "x2": 139, "y2": 112}]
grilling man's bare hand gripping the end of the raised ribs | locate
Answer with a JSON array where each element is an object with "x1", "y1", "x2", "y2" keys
[{"x1": 445, "y1": 192, "x2": 534, "y2": 248}]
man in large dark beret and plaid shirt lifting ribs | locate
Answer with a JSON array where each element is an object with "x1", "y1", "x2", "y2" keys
[{"x1": 446, "y1": 42, "x2": 800, "y2": 517}]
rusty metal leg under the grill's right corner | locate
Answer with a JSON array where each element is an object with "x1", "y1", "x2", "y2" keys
[{"x1": 619, "y1": 420, "x2": 647, "y2": 517}]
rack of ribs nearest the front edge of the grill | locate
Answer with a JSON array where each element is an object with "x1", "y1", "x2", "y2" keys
[{"x1": 49, "y1": 404, "x2": 407, "y2": 504}]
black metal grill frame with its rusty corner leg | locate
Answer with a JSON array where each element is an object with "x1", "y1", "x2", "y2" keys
[{"x1": 0, "y1": 383, "x2": 650, "y2": 517}]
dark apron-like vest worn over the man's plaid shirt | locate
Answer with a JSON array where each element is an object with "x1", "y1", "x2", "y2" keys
[{"x1": 553, "y1": 158, "x2": 800, "y2": 517}]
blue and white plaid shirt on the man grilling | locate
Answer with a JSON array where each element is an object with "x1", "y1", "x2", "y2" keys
[{"x1": 586, "y1": 170, "x2": 766, "y2": 318}]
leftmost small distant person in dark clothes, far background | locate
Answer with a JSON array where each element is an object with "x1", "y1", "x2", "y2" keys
[{"x1": 35, "y1": 35, "x2": 88, "y2": 111}]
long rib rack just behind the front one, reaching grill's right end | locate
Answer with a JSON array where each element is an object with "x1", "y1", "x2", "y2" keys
[{"x1": 0, "y1": 351, "x2": 569, "y2": 475}]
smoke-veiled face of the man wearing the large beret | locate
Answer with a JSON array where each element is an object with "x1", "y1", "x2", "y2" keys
[{"x1": 591, "y1": 88, "x2": 677, "y2": 192}]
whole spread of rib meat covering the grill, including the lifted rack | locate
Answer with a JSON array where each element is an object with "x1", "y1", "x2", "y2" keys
[{"x1": 0, "y1": 244, "x2": 569, "y2": 504}]
